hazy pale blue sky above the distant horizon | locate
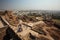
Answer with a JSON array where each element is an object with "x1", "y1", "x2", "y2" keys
[{"x1": 0, "y1": 0, "x2": 60, "y2": 10}]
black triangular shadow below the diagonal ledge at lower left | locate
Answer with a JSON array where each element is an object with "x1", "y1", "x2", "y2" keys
[{"x1": 3, "y1": 27, "x2": 21, "y2": 40}]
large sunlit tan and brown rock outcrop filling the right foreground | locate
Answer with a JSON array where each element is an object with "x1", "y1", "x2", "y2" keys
[{"x1": 15, "y1": 21, "x2": 60, "y2": 40}]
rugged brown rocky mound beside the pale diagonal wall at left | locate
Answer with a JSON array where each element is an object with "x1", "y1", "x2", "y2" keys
[{"x1": 5, "y1": 11, "x2": 19, "y2": 26}]
